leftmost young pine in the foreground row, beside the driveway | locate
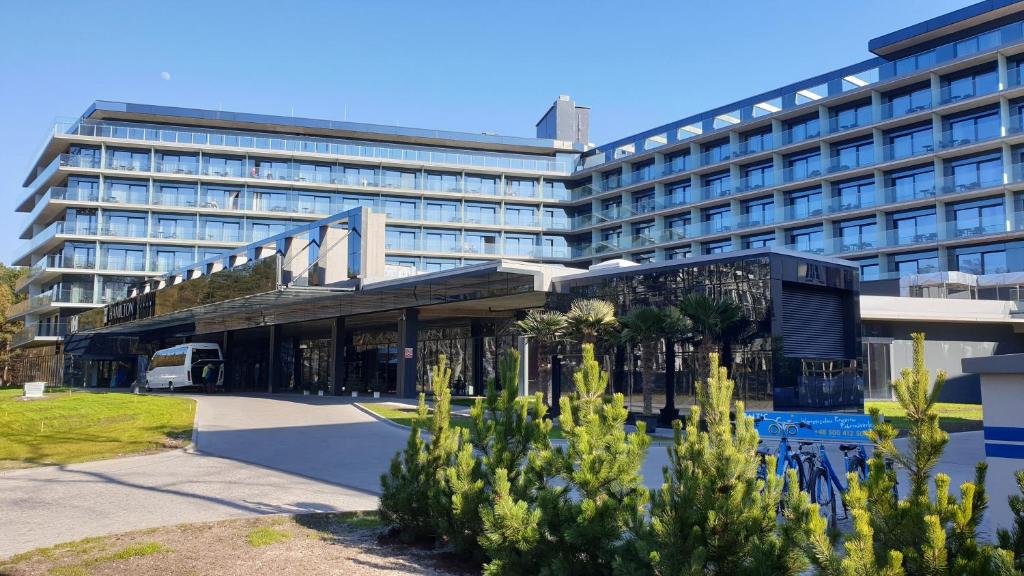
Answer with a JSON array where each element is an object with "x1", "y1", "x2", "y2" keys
[{"x1": 380, "y1": 355, "x2": 459, "y2": 542}]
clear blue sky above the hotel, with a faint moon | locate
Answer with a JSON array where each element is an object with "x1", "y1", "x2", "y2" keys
[{"x1": 0, "y1": 0, "x2": 970, "y2": 262}]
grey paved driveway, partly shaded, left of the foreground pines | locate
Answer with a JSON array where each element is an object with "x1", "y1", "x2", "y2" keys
[{"x1": 0, "y1": 395, "x2": 406, "y2": 558}]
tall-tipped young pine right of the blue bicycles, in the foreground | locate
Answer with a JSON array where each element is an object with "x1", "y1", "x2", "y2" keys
[{"x1": 811, "y1": 333, "x2": 1013, "y2": 576}]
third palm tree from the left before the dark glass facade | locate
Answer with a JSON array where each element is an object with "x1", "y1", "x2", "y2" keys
[{"x1": 618, "y1": 306, "x2": 690, "y2": 416}]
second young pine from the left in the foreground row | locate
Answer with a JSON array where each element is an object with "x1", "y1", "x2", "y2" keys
[{"x1": 440, "y1": 349, "x2": 551, "y2": 562}]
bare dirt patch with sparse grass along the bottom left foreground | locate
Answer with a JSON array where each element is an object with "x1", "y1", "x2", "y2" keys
[{"x1": 0, "y1": 513, "x2": 478, "y2": 576}]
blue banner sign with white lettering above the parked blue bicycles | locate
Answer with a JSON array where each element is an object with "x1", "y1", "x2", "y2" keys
[{"x1": 746, "y1": 411, "x2": 871, "y2": 444}]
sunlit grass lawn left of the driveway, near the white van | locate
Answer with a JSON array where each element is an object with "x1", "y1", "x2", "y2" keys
[{"x1": 0, "y1": 389, "x2": 196, "y2": 469}]
